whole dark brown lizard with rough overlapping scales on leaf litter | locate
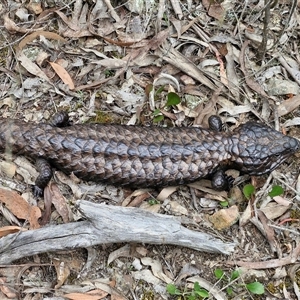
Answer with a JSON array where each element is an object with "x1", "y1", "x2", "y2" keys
[{"x1": 0, "y1": 119, "x2": 299, "y2": 195}]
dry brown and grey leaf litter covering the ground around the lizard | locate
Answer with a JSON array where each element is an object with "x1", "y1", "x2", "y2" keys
[{"x1": 0, "y1": 0, "x2": 300, "y2": 299}]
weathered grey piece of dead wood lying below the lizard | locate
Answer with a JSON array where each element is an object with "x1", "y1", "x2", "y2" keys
[{"x1": 0, "y1": 200, "x2": 235, "y2": 264}]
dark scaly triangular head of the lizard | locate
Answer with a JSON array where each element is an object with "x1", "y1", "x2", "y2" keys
[{"x1": 231, "y1": 122, "x2": 300, "y2": 175}]
